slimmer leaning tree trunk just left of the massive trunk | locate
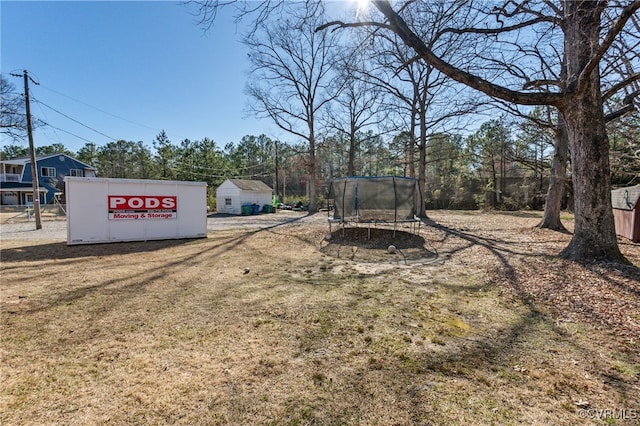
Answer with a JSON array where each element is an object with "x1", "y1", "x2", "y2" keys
[{"x1": 538, "y1": 113, "x2": 569, "y2": 232}]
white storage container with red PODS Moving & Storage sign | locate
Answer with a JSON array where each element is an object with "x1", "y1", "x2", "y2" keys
[{"x1": 64, "y1": 176, "x2": 207, "y2": 245}]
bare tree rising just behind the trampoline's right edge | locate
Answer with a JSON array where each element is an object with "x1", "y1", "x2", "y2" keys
[{"x1": 356, "y1": 2, "x2": 476, "y2": 217}]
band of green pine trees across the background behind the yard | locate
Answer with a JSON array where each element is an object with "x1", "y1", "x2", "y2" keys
[{"x1": 0, "y1": 114, "x2": 640, "y2": 210}]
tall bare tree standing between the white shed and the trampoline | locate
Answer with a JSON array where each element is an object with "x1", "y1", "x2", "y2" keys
[{"x1": 245, "y1": 4, "x2": 338, "y2": 212}]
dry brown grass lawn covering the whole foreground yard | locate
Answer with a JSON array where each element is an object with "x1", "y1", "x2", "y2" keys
[{"x1": 0, "y1": 212, "x2": 640, "y2": 425}]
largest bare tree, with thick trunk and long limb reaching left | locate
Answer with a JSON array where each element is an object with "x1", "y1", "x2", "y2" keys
[{"x1": 319, "y1": 0, "x2": 640, "y2": 262}]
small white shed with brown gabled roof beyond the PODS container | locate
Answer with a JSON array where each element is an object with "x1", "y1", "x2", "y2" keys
[{"x1": 216, "y1": 179, "x2": 273, "y2": 214}]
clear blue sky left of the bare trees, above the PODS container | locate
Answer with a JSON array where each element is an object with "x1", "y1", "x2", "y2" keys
[{"x1": 0, "y1": 0, "x2": 288, "y2": 151}]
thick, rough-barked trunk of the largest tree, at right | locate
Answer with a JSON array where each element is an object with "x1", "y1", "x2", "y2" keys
[{"x1": 561, "y1": 1, "x2": 624, "y2": 262}]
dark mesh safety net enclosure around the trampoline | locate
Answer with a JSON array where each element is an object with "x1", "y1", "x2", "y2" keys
[{"x1": 329, "y1": 176, "x2": 419, "y2": 223}]
